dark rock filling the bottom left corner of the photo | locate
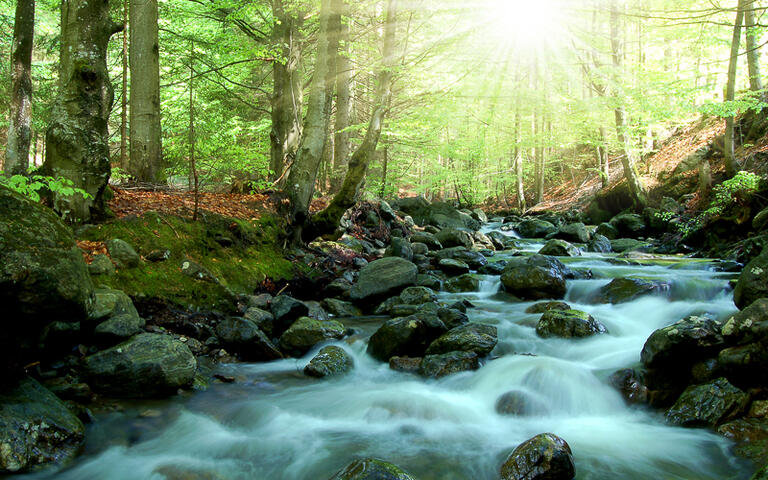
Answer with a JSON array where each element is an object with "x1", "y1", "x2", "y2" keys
[{"x1": 0, "y1": 378, "x2": 85, "y2": 474}]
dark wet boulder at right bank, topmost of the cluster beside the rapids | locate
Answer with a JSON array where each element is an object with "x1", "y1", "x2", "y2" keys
[{"x1": 640, "y1": 315, "x2": 725, "y2": 370}]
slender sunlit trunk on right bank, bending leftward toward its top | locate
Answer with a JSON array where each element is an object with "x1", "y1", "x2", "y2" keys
[{"x1": 611, "y1": 2, "x2": 648, "y2": 209}]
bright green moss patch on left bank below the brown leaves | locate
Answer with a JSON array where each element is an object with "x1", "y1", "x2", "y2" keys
[{"x1": 78, "y1": 212, "x2": 295, "y2": 312}]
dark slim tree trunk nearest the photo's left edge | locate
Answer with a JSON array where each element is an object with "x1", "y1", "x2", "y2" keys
[{"x1": 3, "y1": 0, "x2": 35, "y2": 175}]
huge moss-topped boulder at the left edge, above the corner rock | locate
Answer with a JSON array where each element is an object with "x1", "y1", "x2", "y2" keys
[{"x1": 0, "y1": 186, "x2": 93, "y2": 369}]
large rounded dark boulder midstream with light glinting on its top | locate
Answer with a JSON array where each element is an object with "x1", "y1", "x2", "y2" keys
[{"x1": 501, "y1": 255, "x2": 566, "y2": 300}]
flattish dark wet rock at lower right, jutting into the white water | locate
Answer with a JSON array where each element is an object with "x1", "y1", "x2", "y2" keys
[{"x1": 665, "y1": 377, "x2": 749, "y2": 427}]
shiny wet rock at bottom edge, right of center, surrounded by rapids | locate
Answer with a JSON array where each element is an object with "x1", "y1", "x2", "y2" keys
[{"x1": 501, "y1": 433, "x2": 576, "y2": 480}]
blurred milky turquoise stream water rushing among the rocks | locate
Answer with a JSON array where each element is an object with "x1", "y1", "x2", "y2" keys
[{"x1": 18, "y1": 226, "x2": 752, "y2": 480}]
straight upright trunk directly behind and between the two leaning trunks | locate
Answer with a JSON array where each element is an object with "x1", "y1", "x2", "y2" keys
[{"x1": 331, "y1": 2, "x2": 352, "y2": 193}]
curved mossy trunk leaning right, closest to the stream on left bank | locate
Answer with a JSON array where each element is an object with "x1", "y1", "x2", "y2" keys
[{"x1": 304, "y1": 0, "x2": 397, "y2": 240}]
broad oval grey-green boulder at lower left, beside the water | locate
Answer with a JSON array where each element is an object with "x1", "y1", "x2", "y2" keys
[{"x1": 82, "y1": 333, "x2": 197, "y2": 398}]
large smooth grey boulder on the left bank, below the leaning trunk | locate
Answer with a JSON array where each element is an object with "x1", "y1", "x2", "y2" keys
[{"x1": 349, "y1": 257, "x2": 418, "y2": 301}]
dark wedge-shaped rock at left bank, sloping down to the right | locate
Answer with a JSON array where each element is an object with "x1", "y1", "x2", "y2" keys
[{"x1": 216, "y1": 317, "x2": 283, "y2": 361}]
